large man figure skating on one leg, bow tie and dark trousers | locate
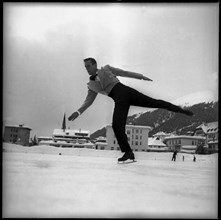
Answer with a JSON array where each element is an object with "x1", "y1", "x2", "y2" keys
[{"x1": 68, "y1": 58, "x2": 193, "y2": 161}]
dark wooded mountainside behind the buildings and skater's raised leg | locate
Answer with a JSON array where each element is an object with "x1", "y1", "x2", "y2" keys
[{"x1": 91, "y1": 101, "x2": 218, "y2": 139}]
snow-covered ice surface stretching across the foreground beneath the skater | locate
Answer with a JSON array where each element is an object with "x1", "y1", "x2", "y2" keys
[{"x1": 2, "y1": 143, "x2": 218, "y2": 219}]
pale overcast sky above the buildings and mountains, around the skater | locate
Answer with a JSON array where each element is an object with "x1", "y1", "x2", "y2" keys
[{"x1": 3, "y1": 3, "x2": 219, "y2": 136}]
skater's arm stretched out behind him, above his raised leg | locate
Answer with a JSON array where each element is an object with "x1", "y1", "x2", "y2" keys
[{"x1": 105, "y1": 65, "x2": 153, "y2": 81}]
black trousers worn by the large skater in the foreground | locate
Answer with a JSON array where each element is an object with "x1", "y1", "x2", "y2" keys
[{"x1": 108, "y1": 83, "x2": 186, "y2": 152}]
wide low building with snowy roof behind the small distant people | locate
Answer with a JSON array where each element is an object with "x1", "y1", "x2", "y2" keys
[{"x1": 165, "y1": 135, "x2": 206, "y2": 152}]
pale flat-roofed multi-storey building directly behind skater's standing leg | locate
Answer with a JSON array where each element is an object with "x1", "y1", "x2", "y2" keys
[{"x1": 106, "y1": 125, "x2": 151, "y2": 151}]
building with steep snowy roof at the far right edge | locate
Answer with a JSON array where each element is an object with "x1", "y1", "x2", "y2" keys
[{"x1": 194, "y1": 121, "x2": 219, "y2": 151}]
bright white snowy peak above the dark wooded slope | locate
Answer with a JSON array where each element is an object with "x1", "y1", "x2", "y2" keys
[{"x1": 172, "y1": 91, "x2": 217, "y2": 107}]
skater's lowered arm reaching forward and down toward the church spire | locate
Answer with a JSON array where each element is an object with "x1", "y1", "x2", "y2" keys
[{"x1": 68, "y1": 89, "x2": 97, "y2": 121}]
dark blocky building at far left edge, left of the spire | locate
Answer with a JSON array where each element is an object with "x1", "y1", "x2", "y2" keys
[{"x1": 3, "y1": 124, "x2": 31, "y2": 146}]
